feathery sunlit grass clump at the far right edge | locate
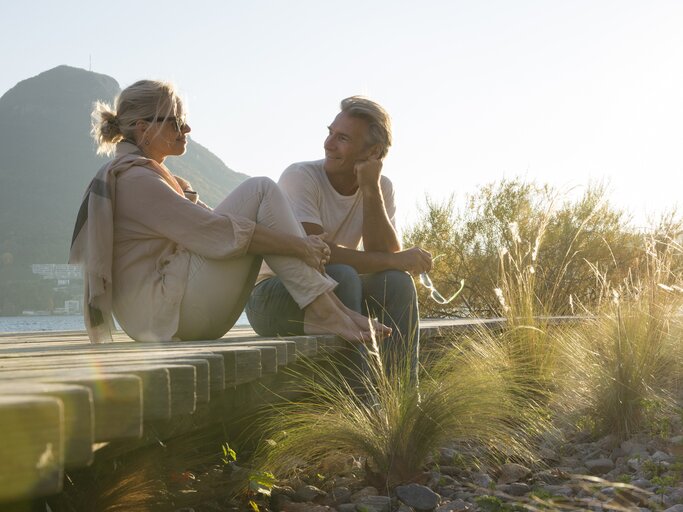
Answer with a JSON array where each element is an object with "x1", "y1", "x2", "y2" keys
[{"x1": 563, "y1": 238, "x2": 683, "y2": 438}]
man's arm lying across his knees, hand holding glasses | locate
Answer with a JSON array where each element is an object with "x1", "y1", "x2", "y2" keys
[{"x1": 302, "y1": 222, "x2": 432, "y2": 274}]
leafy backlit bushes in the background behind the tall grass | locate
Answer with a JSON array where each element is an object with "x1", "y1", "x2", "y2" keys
[{"x1": 404, "y1": 179, "x2": 648, "y2": 317}]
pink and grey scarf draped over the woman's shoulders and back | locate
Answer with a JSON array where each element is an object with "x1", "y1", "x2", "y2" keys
[{"x1": 69, "y1": 142, "x2": 184, "y2": 343}]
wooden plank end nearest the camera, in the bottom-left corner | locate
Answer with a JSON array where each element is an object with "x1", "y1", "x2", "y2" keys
[{"x1": 0, "y1": 395, "x2": 64, "y2": 501}]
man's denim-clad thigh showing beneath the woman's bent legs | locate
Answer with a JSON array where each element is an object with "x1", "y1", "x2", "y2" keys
[{"x1": 245, "y1": 277, "x2": 304, "y2": 336}]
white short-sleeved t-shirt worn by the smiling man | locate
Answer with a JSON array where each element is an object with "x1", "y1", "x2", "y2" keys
[{"x1": 258, "y1": 160, "x2": 396, "y2": 281}]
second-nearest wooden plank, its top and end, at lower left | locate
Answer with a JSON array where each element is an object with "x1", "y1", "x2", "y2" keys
[{"x1": 0, "y1": 381, "x2": 95, "y2": 468}]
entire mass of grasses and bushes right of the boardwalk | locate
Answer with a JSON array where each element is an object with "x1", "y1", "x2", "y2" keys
[{"x1": 256, "y1": 181, "x2": 683, "y2": 494}]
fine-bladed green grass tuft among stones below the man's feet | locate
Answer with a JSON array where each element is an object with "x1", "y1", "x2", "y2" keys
[{"x1": 255, "y1": 337, "x2": 538, "y2": 487}]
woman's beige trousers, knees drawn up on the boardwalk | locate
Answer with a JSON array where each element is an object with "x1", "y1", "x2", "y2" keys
[{"x1": 175, "y1": 178, "x2": 337, "y2": 340}]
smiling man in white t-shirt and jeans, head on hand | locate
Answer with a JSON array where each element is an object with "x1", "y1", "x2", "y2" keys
[{"x1": 246, "y1": 96, "x2": 432, "y2": 380}]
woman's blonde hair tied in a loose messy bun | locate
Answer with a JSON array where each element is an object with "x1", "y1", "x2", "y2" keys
[{"x1": 90, "y1": 80, "x2": 183, "y2": 155}]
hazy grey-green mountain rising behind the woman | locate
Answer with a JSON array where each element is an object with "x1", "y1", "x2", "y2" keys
[{"x1": 0, "y1": 66, "x2": 247, "y2": 268}]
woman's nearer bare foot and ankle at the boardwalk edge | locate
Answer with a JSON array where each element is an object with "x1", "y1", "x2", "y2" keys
[{"x1": 304, "y1": 292, "x2": 372, "y2": 343}]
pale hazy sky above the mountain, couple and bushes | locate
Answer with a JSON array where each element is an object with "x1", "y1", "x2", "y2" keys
[{"x1": 0, "y1": 0, "x2": 683, "y2": 230}]
